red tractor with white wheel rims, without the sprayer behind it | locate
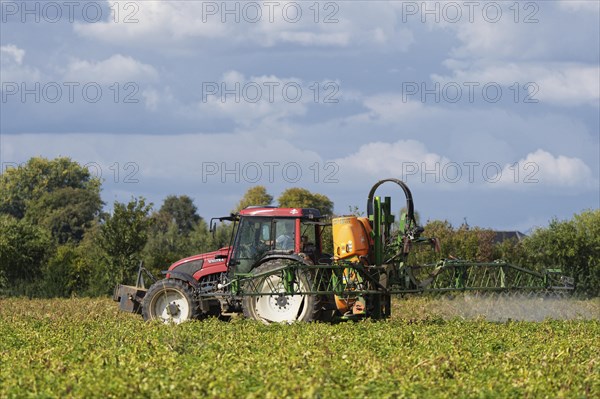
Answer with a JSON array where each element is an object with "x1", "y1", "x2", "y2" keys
[{"x1": 114, "y1": 207, "x2": 332, "y2": 323}]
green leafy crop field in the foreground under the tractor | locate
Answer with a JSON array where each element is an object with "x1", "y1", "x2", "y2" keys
[{"x1": 0, "y1": 298, "x2": 600, "y2": 398}]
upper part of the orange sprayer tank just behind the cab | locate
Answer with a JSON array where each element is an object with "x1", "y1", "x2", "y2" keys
[{"x1": 332, "y1": 216, "x2": 372, "y2": 259}]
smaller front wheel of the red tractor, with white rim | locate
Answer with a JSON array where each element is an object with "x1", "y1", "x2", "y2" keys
[{"x1": 142, "y1": 279, "x2": 199, "y2": 324}]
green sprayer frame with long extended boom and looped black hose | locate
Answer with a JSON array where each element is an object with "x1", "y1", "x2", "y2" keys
[{"x1": 218, "y1": 179, "x2": 573, "y2": 318}]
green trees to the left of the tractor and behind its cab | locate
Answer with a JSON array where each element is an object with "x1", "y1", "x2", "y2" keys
[{"x1": 0, "y1": 158, "x2": 333, "y2": 296}]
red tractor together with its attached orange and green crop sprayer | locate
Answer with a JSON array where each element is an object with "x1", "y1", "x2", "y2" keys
[{"x1": 114, "y1": 179, "x2": 573, "y2": 323}]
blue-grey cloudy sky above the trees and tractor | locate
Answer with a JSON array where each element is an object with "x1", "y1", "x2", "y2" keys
[{"x1": 0, "y1": 0, "x2": 600, "y2": 231}]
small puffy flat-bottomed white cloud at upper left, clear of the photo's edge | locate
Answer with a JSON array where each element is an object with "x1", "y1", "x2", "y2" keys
[{"x1": 65, "y1": 54, "x2": 158, "y2": 84}]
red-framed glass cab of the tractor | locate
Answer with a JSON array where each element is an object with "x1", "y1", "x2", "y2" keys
[{"x1": 228, "y1": 207, "x2": 323, "y2": 274}]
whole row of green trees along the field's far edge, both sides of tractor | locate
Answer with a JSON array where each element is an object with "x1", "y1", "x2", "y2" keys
[{"x1": 0, "y1": 158, "x2": 600, "y2": 296}]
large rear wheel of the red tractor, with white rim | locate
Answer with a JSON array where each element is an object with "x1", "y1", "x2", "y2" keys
[{"x1": 242, "y1": 260, "x2": 321, "y2": 324}]
